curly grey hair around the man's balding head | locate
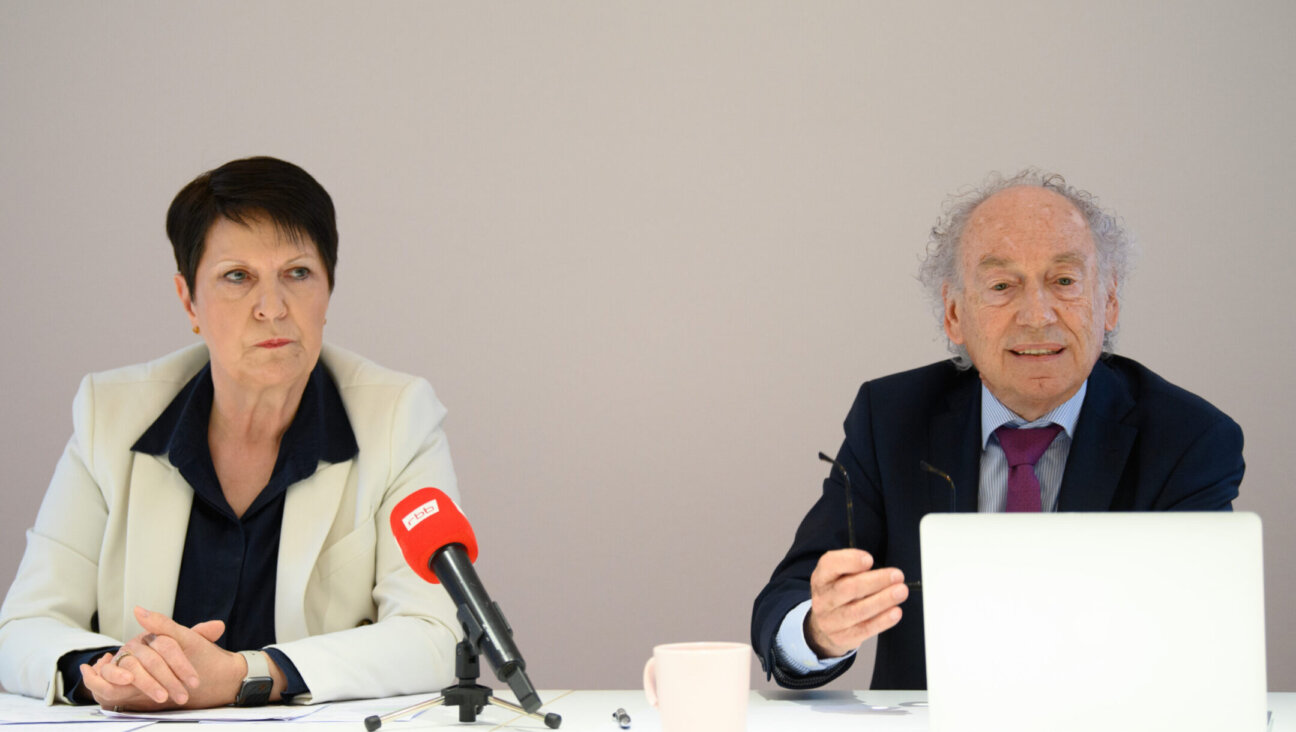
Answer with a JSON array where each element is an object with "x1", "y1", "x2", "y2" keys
[{"x1": 918, "y1": 167, "x2": 1134, "y2": 369}]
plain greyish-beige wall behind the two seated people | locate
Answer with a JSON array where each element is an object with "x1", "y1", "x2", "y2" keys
[{"x1": 0, "y1": 0, "x2": 1296, "y2": 691}]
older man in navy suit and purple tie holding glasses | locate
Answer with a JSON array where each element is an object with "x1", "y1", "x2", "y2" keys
[{"x1": 752, "y1": 170, "x2": 1244, "y2": 689}]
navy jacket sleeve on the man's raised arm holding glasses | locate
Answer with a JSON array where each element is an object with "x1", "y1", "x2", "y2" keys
[{"x1": 752, "y1": 383, "x2": 885, "y2": 689}]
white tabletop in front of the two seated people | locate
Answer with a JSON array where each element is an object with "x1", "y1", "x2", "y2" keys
[{"x1": 0, "y1": 689, "x2": 1296, "y2": 732}]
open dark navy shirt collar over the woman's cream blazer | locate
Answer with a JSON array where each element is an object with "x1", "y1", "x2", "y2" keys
[{"x1": 131, "y1": 361, "x2": 359, "y2": 475}]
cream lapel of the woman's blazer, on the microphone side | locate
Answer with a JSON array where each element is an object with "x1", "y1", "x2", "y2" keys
[{"x1": 275, "y1": 460, "x2": 354, "y2": 641}]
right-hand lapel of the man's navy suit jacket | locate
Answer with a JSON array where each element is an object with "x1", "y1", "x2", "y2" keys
[{"x1": 1058, "y1": 359, "x2": 1138, "y2": 510}]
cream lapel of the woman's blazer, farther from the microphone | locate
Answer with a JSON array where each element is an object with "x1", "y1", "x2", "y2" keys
[{"x1": 122, "y1": 453, "x2": 193, "y2": 639}]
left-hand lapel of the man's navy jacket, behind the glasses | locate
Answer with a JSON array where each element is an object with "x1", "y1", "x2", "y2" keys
[{"x1": 914, "y1": 371, "x2": 981, "y2": 513}]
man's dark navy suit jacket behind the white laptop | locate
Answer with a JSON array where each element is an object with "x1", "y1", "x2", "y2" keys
[{"x1": 752, "y1": 356, "x2": 1244, "y2": 689}]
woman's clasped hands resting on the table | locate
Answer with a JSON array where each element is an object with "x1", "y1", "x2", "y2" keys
[{"x1": 80, "y1": 608, "x2": 246, "y2": 711}]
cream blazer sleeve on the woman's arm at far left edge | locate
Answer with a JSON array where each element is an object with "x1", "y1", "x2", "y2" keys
[{"x1": 0, "y1": 377, "x2": 121, "y2": 703}]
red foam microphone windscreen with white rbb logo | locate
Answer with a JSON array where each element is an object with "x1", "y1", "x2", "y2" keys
[{"x1": 391, "y1": 488, "x2": 477, "y2": 583}]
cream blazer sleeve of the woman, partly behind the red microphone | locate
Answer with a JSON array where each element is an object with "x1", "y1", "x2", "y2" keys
[{"x1": 265, "y1": 380, "x2": 461, "y2": 703}]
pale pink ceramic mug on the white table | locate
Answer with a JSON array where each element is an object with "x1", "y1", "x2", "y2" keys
[{"x1": 644, "y1": 643, "x2": 752, "y2": 732}]
